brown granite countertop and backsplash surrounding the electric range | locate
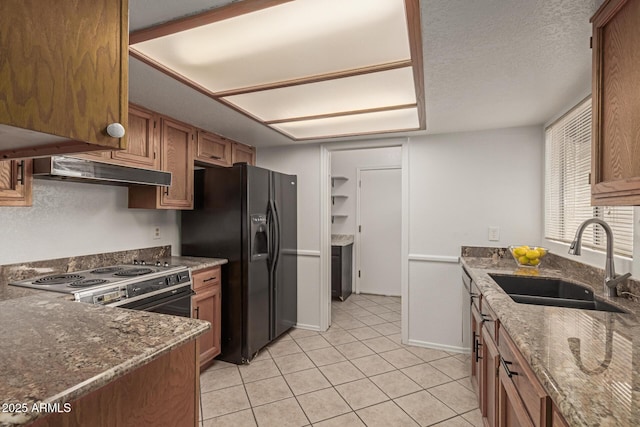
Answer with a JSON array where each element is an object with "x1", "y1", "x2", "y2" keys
[{"x1": 0, "y1": 251, "x2": 218, "y2": 426}]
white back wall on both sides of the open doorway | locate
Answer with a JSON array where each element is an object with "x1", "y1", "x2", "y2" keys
[{"x1": 258, "y1": 126, "x2": 543, "y2": 350}]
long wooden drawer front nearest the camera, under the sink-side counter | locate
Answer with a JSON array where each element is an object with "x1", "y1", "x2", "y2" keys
[{"x1": 498, "y1": 328, "x2": 551, "y2": 427}]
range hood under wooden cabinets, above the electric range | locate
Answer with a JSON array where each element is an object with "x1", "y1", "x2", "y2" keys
[{"x1": 33, "y1": 156, "x2": 171, "y2": 187}]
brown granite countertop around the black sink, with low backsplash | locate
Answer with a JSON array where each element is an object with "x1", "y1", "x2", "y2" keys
[{"x1": 461, "y1": 250, "x2": 640, "y2": 426}]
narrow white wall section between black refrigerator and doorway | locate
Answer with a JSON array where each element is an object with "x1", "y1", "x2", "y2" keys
[{"x1": 256, "y1": 145, "x2": 320, "y2": 329}]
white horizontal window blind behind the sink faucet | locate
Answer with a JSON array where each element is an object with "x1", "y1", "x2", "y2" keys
[{"x1": 545, "y1": 98, "x2": 633, "y2": 256}]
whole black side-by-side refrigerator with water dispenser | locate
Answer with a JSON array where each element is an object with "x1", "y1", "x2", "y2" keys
[{"x1": 181, "y1": 163, "x2": 298, "y2": 364}]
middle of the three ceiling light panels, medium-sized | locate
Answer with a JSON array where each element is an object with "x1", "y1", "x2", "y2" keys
[{"x1": 222, "y1": 67, "x2": 416, "y2": 122}]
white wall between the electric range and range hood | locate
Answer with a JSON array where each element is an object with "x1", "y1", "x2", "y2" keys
[{"x1": 0, "y1": 179, "x2": 180, "y2": 265}]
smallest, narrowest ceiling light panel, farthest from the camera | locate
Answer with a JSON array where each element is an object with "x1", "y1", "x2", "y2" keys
[{"x1": 271, "y1": 108, "x2": 420, "y2": 139}]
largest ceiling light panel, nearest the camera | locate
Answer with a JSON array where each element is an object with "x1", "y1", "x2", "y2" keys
[{"x1": 132, "y1": 0, "x2": 411, "y2": 93}]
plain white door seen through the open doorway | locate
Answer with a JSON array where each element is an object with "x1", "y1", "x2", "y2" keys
[{"x1": 356, "y1": 168, "x2": 402, "y2": 296}]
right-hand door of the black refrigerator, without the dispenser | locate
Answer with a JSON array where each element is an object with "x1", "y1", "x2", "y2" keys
[{"x1": 271, "y1": 172, "x2": 298, "y2": 339}]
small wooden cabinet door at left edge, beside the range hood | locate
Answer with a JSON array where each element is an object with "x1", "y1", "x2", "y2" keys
[{"x1": 0, "y1": 160, "x2": 33, "y2": 206}]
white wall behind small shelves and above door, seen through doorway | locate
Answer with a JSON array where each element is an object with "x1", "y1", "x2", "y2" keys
[{"x1": 331, "y1": 147, "x2": 402, "y2": 234}]
